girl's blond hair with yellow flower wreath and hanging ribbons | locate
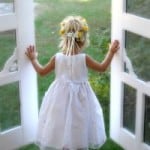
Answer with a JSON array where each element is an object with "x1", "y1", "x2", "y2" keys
[{"x1": 59, "y1": 16, "x2": 89, "y2": 55}]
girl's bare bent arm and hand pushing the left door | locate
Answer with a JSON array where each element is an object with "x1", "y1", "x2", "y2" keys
[{"x1": 25, "y1": 46, "x2": 55, "y2": 76}]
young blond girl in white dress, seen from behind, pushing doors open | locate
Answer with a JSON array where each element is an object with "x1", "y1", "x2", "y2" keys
[{"x1": 26, "y1": 16, "x2": 119, "y2": 150}]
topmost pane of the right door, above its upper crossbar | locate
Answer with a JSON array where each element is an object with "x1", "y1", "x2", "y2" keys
[{"x1": 126, "y1": 0, "x2": 150, "y2": 18}]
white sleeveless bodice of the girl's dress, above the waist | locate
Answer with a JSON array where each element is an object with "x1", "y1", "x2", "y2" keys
[{"x1": 55, "y1": 53, "x2": 88, "y2": 82}]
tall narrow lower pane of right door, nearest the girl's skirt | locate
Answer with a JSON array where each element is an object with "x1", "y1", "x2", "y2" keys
[{"x1": 123, "y1": 84, "x2": 136, "y2": 133}]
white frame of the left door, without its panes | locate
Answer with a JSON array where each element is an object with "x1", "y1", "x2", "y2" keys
[{"x1": 0, "y1": 0, "x2": 38, "y2": 150}]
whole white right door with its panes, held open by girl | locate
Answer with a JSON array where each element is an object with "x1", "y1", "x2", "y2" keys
[{"x1": 110, "y1": 0, "x2": 150, "y2": 150}]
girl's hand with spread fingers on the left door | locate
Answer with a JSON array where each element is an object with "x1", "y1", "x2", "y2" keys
[{"x1": 25, "y1": 45, "x2": 38, "y2": 61}]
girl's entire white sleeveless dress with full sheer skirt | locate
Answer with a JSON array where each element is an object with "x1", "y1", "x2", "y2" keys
[{"x1": 36, "y1": 53, "x2": 106, "y2": 150}]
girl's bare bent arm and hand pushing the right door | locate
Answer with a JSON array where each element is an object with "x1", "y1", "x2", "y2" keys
[{"x1": 86, "y1": 40, "x2": 119, "y2": 72}]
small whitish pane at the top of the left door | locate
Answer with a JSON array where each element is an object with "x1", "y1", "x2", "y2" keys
[{"x1": 0, "y1": 0, "x2": 14, "y2": 14}]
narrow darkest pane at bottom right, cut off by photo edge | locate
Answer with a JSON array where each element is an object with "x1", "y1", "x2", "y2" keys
[{"x1": 144, "y1": 95, "x2": 150, "y2": 145}]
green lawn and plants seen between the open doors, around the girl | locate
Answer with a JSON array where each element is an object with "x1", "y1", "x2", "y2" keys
[{"x1": 19, "y1": 0, "x2": 122, "y2": 150}]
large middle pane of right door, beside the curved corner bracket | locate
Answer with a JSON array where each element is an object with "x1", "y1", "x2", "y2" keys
[{"x1": 125, "y1": 31, "x2": 150, "y2": 81}]
